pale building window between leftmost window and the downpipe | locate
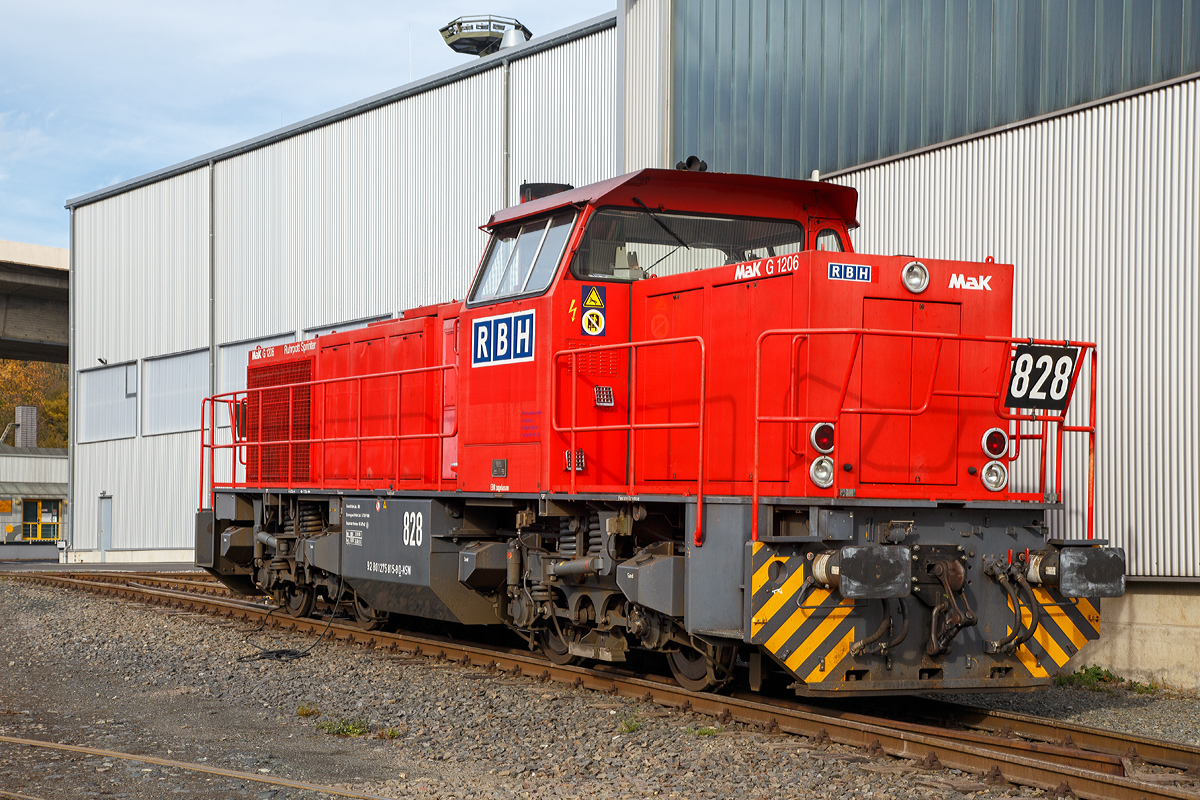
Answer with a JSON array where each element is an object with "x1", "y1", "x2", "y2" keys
[{"x1": 142, "y1": 350, "x2": 209, "y2": 437}]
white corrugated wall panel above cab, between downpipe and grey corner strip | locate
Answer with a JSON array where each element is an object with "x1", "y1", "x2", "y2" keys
[{"x1": 506, "y1": 28, "x2": 622, "y2": 201}]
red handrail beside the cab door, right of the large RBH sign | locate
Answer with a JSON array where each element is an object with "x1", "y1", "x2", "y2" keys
[{"x1": 550, "y1": 336, "x2": 708, "y2": 547}]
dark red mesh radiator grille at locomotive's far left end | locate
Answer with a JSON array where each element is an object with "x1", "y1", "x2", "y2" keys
[{"x1": 246, "y1": 360, "x2": 312, "y2": 486}]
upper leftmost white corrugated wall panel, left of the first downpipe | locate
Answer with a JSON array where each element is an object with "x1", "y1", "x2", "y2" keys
[{"x1": 71, "y1": 169, "x2": 209, "y2": 366}]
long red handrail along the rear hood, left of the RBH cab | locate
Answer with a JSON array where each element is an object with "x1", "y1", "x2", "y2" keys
[{"x1": 199, "y1": 363, "x2": 458, "y2": 510}]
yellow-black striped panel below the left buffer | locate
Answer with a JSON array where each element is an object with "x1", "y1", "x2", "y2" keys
[{"x1": 750, "y1": 542, "x2": 858, "y2": 684}]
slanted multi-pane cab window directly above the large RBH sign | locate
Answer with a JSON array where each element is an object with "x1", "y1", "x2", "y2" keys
[{"x1": 470, "y1": 209, "x2": 575, "y2": 302}]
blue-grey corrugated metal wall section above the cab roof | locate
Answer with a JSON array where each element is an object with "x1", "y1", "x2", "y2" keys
[{"x1": 672, "y1": 0, "x2": 1200, "y2": 178}]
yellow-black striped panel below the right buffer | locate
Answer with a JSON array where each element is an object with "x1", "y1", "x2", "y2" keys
[{"x1": 1006, "y1": 589, "x2": 1100, "y2": 678}]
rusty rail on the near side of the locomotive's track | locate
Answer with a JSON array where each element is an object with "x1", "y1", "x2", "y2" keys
[{"x1": 12, "y1": 573, "x2": 1200, "y2": 800}]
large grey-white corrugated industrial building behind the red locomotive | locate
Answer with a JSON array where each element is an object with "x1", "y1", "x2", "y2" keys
[{"x1": 68, "y1": 0, "x2": 1200, "y2": 684}]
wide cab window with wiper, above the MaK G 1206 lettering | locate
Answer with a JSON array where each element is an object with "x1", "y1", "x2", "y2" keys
[{"x1": 571, "y1": 209, "x2": 804, "y2": 281}]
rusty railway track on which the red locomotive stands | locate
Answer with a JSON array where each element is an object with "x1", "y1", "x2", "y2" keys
[{"x1": 10, "y1": 572, "x2": 1200, "y2": 800}]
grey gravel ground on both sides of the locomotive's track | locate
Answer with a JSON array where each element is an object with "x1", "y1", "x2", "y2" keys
[{"x1": 0, "y1": 581, "x2": 1200, "y2": 800}]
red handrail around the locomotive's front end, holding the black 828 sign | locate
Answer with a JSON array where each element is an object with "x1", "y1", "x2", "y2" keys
[{"x1": 751, "y1": 327, "x2": 1098, "y2": 541}]
